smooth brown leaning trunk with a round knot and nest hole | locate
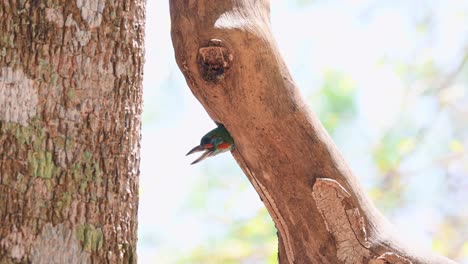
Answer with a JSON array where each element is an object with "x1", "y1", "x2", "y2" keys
[{"x1": 170, "y1": 0, "x2": 454, "y2": 264}]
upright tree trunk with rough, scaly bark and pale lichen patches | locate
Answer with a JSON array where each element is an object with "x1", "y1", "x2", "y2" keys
[{"x1": 0, "y1": 0, "x2": 145, "y2": 264}]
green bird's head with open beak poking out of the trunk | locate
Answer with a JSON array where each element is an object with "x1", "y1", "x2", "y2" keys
[{"x1": 185, "y1": 123, "x2": 234, "y2": 165}]
